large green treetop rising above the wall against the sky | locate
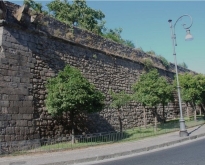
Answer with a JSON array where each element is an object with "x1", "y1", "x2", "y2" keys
[{"x1": 47, "y1": 0, "x2": 105, "y2": 34}]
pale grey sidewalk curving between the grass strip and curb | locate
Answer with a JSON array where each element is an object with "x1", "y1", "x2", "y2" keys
[{"x1": 0, "y1": 125, "x2": 205, "y2": 165}]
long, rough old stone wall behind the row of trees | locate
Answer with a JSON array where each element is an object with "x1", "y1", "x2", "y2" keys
[{"x1": 0, "y1": 2, "x2": 199, "y2": 152}]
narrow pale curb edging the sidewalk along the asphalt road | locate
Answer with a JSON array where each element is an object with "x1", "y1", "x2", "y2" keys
[{"x1": 41, "y1": 133, "x2": 205, "y2": 165}]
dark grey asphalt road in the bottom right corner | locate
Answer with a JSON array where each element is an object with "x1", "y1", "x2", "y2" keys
[{"x1": 92, "y1": 139, "x2": 205, "y2": 165}]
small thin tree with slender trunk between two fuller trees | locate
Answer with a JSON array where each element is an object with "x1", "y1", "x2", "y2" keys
[{"x1": 110, "y1": 91, "x2": 131, "y2": 132}]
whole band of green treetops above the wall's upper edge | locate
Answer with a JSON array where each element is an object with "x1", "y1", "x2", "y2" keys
[{"x1": 24, "y1": 0, "x2": 135, "y2": 48}]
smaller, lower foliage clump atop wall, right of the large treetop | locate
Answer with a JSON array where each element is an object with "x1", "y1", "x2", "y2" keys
[{"x1": 103, "y1": 28, "x2": 135, "y2": 48}]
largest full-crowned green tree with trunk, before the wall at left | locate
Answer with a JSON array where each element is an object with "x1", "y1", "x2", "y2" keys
[{"x1": 45, "y1": 65, "x2": 105, "y2": 142}]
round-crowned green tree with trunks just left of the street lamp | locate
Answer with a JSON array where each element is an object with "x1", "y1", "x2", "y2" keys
[{"x1": 132, "y1": 69, "x2": 173, "y2": 126}]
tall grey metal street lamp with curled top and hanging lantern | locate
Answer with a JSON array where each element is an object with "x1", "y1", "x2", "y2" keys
[{"x1": 168, "y1": 15, "x2": 193, "y2": 137}]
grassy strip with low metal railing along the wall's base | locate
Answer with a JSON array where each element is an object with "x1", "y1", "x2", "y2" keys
[{"x1": 0, "y1": 117, "x2": 205, "y2": 155}]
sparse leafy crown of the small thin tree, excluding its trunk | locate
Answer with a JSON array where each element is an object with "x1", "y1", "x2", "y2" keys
[{"x1": 110, "y1": 91, "x2": 131, "y2": 110}]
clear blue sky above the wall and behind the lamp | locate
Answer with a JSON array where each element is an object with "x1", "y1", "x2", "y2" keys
[{"x1": 11, "y1": 0, "x2": 205, "y2": 74}]
